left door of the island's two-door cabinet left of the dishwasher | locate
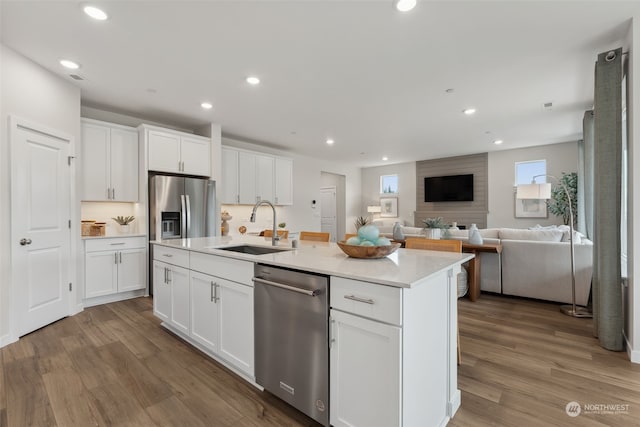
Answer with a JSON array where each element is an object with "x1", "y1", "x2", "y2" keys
[{"x1": 190, "y1": 271, "x2": 220, "y2": 353}]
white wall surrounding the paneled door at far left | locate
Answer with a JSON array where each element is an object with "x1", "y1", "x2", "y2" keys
[{"x1": 0, "y1": 45, "x2": 80, "y2": 346}]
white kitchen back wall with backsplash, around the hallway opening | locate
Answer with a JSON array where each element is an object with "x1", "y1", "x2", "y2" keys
[{"x1": 222, "y1": 137, "x2": 361, "y2": 235}]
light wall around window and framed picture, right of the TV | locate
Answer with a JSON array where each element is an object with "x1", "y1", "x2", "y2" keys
[{"x1": 487, "y1": 142, "x2": 578, "y2": 228}]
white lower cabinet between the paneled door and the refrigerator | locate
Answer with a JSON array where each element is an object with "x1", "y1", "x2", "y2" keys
[{"x1": 84, "y1": 237, "x2": 147, "y2": 306}]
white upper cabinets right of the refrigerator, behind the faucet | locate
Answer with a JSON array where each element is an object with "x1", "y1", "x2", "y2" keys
[{"x1": 220, "y1": 147, "x2": 293, "y2": 205}]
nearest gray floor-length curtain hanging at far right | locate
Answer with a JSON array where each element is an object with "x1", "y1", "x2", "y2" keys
[{"x1": 592, "y1": 49, "x2": 624, "y2": 351}]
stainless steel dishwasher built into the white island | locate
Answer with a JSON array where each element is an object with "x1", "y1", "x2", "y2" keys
[{"x1": 253, "y1": 264, "x2": 329, "y2": 426}]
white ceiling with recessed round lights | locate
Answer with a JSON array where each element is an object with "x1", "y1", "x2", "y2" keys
[{"x1": 0, "y1": 0, "x2": 640, "y2": 167}]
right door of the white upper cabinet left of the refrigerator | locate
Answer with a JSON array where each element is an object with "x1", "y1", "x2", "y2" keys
[{"x1": 109, "y1": 128, "x2": 138, "y2": 202}]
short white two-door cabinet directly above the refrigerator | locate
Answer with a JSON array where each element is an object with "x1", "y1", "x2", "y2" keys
[{"x1": 143, "y1": 125, "x2": 211, "y2": 177}]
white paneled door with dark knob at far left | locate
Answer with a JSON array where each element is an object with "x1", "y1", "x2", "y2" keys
[{"x1": 10, "y1": 119, "x2": 72, "y2": 336}]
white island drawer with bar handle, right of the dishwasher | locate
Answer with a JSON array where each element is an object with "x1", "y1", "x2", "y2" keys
[{"x1": 330, "y1": 276, "x2": 402, "y2": 325}]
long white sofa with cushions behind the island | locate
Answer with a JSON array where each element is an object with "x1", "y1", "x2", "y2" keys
[{"x1": 374, "y1": 221, "x2": 593, "y2": 305}]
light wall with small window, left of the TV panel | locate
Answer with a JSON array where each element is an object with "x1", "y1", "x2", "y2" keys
[{"x1": 362, "y1": 162, "x2": 416, "y2": 226}]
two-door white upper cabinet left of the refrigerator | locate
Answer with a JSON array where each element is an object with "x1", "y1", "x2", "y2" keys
[{"x1": 82, "y1": 119, "x2": 138, "y2": 202}]
